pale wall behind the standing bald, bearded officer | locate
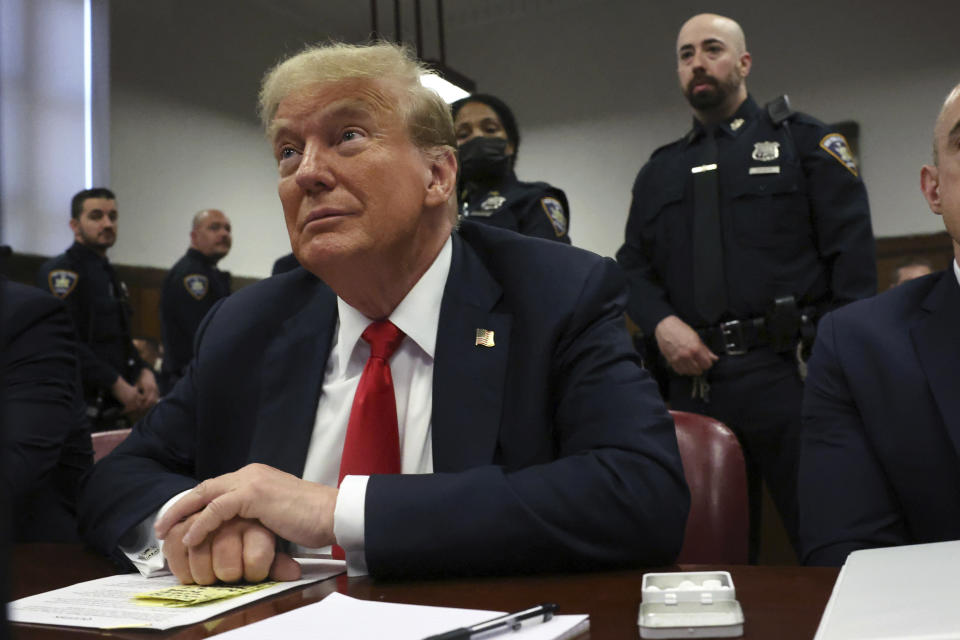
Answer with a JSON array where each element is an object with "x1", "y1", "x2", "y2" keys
[{"x1": 450, "y1": 0, "x2": 960, "y2": 255}]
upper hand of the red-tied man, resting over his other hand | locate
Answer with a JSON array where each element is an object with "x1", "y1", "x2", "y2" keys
[{"x1": 154, "y1": 464, "x2": 337, "y2": 547}]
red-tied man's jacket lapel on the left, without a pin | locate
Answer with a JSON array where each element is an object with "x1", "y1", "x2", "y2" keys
[{"x1": 250, "y1": 281, "x2": 337, "y2": 476}]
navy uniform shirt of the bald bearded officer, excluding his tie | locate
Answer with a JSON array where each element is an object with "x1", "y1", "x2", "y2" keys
[{"x1": 617, "y1": 97, "x2": 877, "y2": 335}]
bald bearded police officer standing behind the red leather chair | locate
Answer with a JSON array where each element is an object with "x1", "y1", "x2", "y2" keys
[{"x1": 617, "y1": 14, "x2": 876, "y2": 560}]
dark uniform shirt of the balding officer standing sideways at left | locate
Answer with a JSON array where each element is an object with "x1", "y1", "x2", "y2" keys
[{"x1": 160, "y1": 249, "x2": 230, "y2": 378}]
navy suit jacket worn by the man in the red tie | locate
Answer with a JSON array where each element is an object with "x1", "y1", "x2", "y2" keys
[{"x1": 81, "y1": 223, "x2": 689, "y2": 576}]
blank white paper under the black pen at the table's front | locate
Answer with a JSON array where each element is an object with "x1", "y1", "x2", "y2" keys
[{"x1": 217, "y1": 593, "x2": 590, "y2": 640}]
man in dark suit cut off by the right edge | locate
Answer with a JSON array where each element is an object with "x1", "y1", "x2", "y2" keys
[{"x1": 800, "y1": 86, "x2": 960, "y2": 565}]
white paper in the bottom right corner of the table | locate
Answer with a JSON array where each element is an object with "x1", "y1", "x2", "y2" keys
[{"x1": 815, "y1": 542, "x2": 960, "y2": 640}]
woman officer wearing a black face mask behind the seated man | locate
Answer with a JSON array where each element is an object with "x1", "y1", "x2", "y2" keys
[{"x1": 451, "y1": 93, "x2": 570, "y2": 244}]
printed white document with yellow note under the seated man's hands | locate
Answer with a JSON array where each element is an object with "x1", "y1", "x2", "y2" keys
[{"x1": 7, "y1": 558, "x2": 345, "y2": 629}]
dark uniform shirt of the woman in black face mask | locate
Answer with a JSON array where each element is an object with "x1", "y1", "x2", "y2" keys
[{"x1": 460, "y1": 171, "x2": 570, "y2": 244}]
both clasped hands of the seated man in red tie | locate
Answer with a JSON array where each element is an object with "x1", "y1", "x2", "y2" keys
[{"x1": 154, "y1": 464, "x2": 337, "y2": 585}]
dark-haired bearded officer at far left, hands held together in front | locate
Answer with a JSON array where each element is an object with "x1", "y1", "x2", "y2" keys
[{"x1": 37, "y1": 188, "x2": 157, "y2": 430}]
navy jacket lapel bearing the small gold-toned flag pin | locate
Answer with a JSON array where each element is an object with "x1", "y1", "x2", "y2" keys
[{"x1": 432, "y1": 233, "x2": 511, "y2": 471}]
